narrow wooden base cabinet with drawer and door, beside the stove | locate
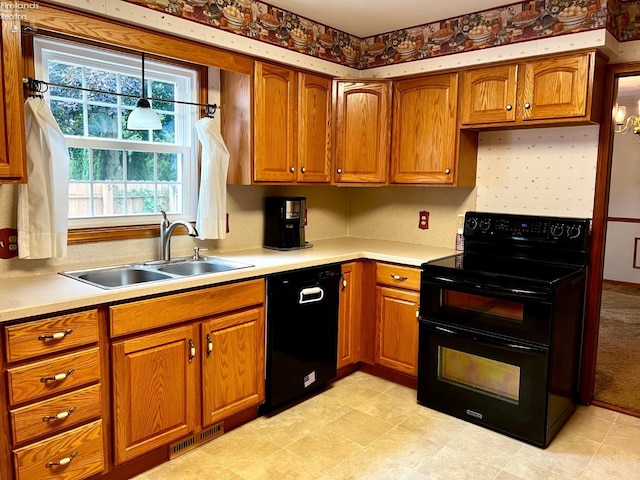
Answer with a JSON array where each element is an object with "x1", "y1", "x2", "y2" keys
[{"x1": 374, "y1": 264, "x2": 420, "y2": 377}]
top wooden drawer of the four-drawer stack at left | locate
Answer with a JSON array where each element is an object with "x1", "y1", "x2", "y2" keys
[{"x1": 5, "y1": 310, "x2": 98, "y2": 363}]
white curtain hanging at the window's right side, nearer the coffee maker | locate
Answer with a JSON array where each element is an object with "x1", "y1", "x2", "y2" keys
[{"x1": 196, "y1": 117, "x2": 229, "y2": 240}]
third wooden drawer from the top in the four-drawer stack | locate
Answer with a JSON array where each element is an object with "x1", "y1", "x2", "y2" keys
[{"x1": 10, "y1": 385, "x2": 102, "y2": 445}]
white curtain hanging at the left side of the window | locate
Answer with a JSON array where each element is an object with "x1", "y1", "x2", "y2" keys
[{"x1": 18, "y1": 98, "x2": 69, "y2": 259}]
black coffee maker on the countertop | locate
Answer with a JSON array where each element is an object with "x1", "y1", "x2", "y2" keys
[{"x1": 264, "y1": 197, "x2": 311, "y2": 250}]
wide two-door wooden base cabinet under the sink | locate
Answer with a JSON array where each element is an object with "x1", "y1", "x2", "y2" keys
[{"x1": 111, "y1": 279, "x2": 265, "y2": 465}]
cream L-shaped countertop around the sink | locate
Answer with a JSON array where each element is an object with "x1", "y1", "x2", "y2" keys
[{"x1": 0, "y1": 237, "x2": 457, "y2": 322}]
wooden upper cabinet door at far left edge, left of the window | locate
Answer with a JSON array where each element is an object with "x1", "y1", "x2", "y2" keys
[{"x1": 0, "y1": 20, "x2": 27, "y2": 182}]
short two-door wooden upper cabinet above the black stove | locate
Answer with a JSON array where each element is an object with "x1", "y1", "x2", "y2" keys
[{"x1": 461, "y1": 51, "x2": 606, "y2": 128}]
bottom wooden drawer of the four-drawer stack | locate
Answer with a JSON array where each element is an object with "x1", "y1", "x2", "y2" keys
[{"x1": 13, "y1": 420, "x2": 104, "y2": 480}]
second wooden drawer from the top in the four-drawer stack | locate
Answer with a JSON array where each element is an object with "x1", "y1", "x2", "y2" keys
[{"x1": 7, "y1": 347, "x2": 100, "y2": 406}]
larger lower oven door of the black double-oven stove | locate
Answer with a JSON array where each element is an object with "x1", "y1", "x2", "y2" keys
[{"x1": 418, "y1": 320, "x2": 549, "y2": 446}]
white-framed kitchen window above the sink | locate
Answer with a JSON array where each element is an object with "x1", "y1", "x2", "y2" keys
[{"x1": 34, "y1": 37, "x2": 198, "y2": 234}]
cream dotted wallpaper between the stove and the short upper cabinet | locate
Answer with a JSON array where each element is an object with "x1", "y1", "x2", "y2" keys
[{"x1": 476, "y1": 125, "x2": 598, "y2": 218}]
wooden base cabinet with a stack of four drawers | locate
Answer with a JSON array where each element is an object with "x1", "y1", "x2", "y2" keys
[{"x1": 0, "y1": 309, "x2": 109, "y2": 480}]
